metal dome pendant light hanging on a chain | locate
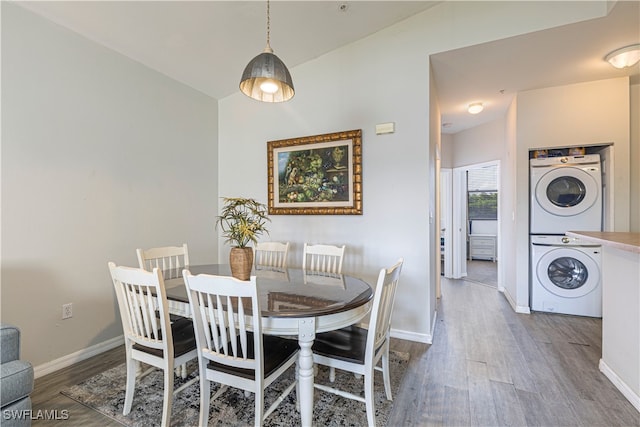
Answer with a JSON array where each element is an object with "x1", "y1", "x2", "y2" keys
[{"x1": 240, "y1": 0, "x2": 295, "y2": 102}]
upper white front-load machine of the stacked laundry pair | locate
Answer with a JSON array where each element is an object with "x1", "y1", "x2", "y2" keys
[{"x1": 529, "y1": 154, "x2": 602, "y2": 234}]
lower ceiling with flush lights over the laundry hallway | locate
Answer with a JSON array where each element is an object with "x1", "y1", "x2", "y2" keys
[{"x1": 431, "y1": 1, "x2": 640, "y2": 133}]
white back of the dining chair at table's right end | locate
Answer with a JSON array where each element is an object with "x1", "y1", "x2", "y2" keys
[{"x1": 366, "y1": 258, "x2": 404, "y2": 352}]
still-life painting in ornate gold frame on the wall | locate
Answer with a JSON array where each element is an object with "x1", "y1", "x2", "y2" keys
[{"x1": 267, "y1": 129, "x2": 362, "y2": 215}]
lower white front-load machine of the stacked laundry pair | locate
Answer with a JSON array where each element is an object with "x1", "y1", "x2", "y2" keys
[{"x1": 531, "y1": 236, "x2": 602, "y2": 317}]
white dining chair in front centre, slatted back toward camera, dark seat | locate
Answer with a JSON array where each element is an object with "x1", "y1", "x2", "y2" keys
[{"x1": 183, "y1": 270, "x2": 299, "y2": 426}]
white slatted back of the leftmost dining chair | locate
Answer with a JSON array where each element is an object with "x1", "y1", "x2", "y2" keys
[{"x1": 109, "y1": 262, "x2": 173, "y2": 357}]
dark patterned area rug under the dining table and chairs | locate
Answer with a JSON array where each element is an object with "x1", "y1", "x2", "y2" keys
[{"x1": 61, "y1": 351, "x2": 409, "y2": 427}]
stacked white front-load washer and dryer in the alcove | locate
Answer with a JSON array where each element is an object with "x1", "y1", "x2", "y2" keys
[{"x1": 529, "y1": 154, "x2": 603, "y2": 317}]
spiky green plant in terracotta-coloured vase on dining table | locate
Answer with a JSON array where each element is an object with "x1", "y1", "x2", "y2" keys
[{"x1": 216, "y1": 197, "x2": 271, "y2": 280}]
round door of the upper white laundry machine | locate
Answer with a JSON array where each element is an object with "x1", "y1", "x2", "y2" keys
[{"x1": 535, "y1": 166, "x2": 600, "y2": 216}]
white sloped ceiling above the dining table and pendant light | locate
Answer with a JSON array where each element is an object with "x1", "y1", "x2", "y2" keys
[{"x1": 17, "y1": 0, "x2": 438, "y2": 99}]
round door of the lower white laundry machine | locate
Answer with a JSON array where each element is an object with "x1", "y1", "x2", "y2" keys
[{"x1": 536, "y1": 247, "x2": 600, "y2": 298}]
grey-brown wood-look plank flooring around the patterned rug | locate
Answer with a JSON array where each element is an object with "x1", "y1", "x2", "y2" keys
[{"x1": 32, "y1": 278, "x2": 640, "y2": 427}]
